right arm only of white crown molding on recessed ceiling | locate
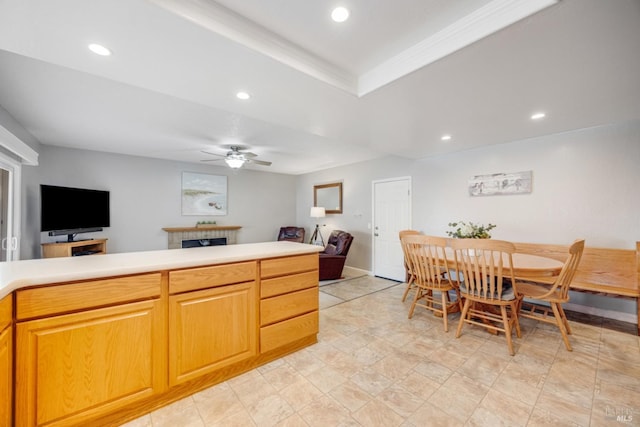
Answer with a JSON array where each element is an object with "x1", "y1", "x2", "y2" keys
[{"x1": 358, "y1": 0, "x2": 559, "y2": 96}]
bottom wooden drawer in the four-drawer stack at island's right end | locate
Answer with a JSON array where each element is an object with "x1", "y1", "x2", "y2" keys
[{"x1": 260, "y1": 311, "x2": 318, "y2": 353}]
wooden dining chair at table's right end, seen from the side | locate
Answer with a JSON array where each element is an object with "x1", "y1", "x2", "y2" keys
[{"x1": 518, "y1": 240, "x2": 584, "y2": 351}]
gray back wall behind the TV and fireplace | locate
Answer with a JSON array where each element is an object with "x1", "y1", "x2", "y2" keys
[{"x1": 21, "y1": 145, "x2": 296, "y2": 259}]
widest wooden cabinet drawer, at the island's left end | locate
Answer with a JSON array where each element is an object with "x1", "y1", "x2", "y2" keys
[{"x1": 16, "y1": 273, "x2": 161, "y2": 320}]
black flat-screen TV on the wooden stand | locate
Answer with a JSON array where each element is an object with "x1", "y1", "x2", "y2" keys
[{"x1": 40, "y1": 185, "x2": 110, "y2": 235}]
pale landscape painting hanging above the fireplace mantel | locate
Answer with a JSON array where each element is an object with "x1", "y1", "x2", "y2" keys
[{"x1": 182, "y1": 172, "x2": 227, "y2": 215}]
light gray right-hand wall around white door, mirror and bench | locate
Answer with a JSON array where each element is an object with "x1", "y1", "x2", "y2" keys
[{"x1": 297, "y1": 121, "x2": 640, "y2": 320}]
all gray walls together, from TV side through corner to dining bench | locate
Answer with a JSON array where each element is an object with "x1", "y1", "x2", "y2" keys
[{"x1": 13, "y1": 122, "x2": 640, "y2": 321}]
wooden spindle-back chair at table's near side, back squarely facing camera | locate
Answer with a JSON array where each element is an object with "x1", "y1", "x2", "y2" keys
[{"x1": 450, "y1": 239, "x2": 522, "y2": 356}]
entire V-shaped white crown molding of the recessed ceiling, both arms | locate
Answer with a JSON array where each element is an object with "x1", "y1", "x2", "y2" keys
[{"x1": 149, "y1": 0, "x2": 560, "y2": 97}]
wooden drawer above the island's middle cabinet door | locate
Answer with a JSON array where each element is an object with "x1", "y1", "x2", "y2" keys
[{"x1": 169, "y1": 261, "x2": 256, "y2": 294}]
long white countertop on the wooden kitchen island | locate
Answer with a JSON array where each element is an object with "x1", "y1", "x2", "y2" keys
[{"x1": 0, "y1": 241, "x2": 323, "y2": 298}]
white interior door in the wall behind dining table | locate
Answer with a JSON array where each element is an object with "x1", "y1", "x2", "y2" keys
[{"x1": 373, "y1": 177, "x2": 411, "y2": 281}]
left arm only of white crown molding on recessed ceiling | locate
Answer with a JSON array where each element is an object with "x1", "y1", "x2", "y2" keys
[{"x1": 150, "y1": 0, "x2": 357, "y2": 95}]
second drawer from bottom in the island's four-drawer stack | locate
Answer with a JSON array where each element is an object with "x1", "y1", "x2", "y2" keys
[{"x1": 260, "y1": 288, "x2": 318, "y2": 326}]
